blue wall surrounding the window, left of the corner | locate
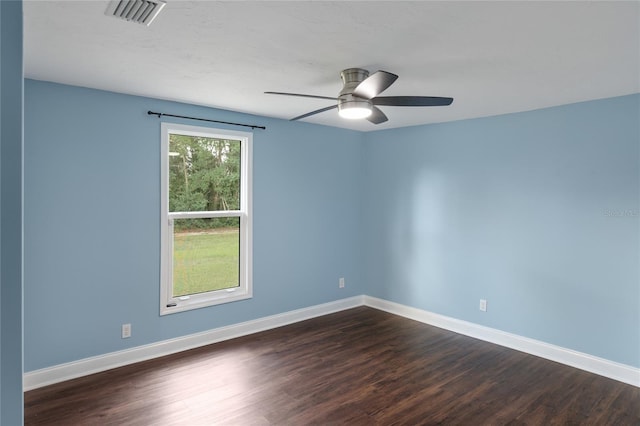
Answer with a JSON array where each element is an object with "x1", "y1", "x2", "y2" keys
[{"x1": 24, "y1": 80, "x2": 364, "y2": 371}]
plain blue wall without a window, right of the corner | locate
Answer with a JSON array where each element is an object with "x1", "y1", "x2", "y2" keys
[{"x1": 363, "y1": 95, "x2": 640, "y2": 367}]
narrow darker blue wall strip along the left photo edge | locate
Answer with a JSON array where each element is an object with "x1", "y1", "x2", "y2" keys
[{"x1": 0, "y1": 1, "x2": 23, "y2": 425}]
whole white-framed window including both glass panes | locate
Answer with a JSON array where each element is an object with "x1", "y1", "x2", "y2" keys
[{"x1": 160, "y1": 123, "x2": 252, "y2": 315}]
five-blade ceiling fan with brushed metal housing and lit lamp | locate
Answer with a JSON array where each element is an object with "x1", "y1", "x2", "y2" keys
[{"x1": 264, "y1": 68, "x2": 453, "y2": 124}]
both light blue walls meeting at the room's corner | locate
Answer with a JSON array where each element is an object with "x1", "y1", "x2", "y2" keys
[{"x1": 24, "y1": 80, "x2": 640, "y2": 371}]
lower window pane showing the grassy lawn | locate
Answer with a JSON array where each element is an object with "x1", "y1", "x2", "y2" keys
[{"x1": 173, "y1": 217, "x2": 240, "y2": 296}]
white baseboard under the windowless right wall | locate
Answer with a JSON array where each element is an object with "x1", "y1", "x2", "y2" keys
[{"x1": 364, "y1": 296, "x2": 640, "y2": 387}]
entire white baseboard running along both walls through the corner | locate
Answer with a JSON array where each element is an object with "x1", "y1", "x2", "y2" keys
[{"x1": 23, "y1": 296, "x2": 640, "y2": 391}]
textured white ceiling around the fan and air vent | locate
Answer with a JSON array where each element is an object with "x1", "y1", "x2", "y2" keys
[{"x1": 24, "y1": 0, "x2": 640, "y2": 131}]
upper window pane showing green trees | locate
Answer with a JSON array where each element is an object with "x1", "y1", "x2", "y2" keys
[{"x1": 169, "y1": 133, "x2": 241, "y2": 212}]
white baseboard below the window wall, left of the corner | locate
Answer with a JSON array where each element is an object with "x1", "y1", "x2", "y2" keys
[{"x1": 23, "y1": 296, "x2": 364, "y2": 391}]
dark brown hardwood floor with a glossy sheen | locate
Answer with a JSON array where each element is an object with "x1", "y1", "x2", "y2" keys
[{"x1": 25, "y1": 307, "x2": 640, "y2": 426}]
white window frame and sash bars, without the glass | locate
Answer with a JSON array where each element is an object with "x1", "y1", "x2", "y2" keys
[{"x1": 160, "y1": 123, "x2": 253, "y2": 315}]
